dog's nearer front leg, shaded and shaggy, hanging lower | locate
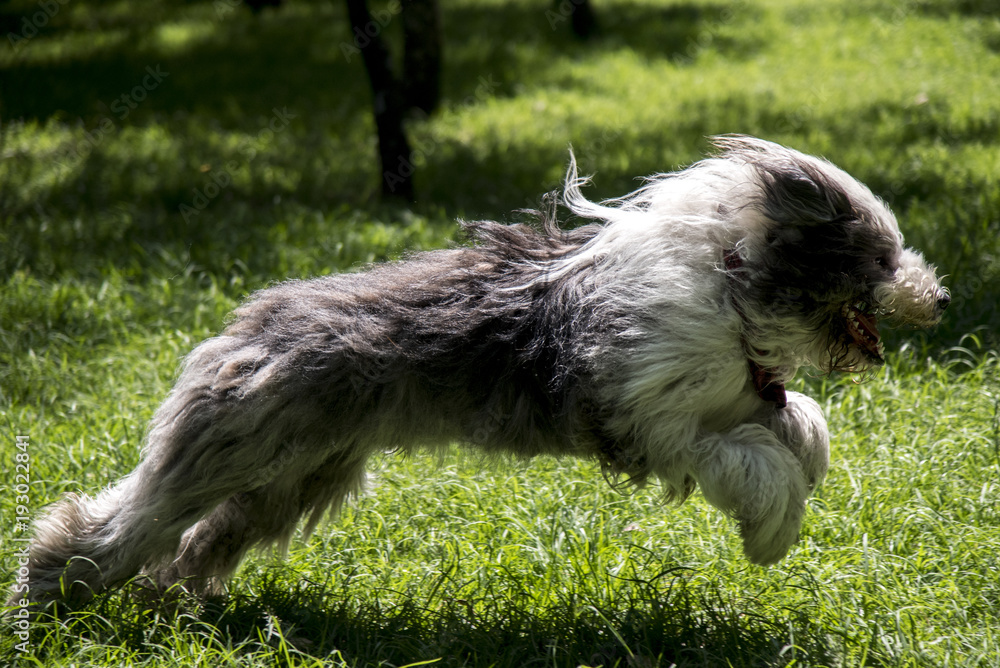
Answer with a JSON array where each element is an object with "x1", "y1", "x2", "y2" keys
[{"x1": 694, "y1": 424, "x2": 809, "y2": 565}]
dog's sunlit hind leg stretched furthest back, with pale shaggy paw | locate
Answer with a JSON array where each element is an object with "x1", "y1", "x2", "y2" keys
[{"x1": 21, "y1": 370, "x2": 302, "y2": 606}]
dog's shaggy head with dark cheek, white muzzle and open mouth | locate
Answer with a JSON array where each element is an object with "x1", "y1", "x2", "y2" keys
[{"x1": 717, "y1": 137, "x2": 951, "y2": 372}]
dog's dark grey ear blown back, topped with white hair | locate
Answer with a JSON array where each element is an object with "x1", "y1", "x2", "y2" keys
[{"x1": 715, "y1": 135, "x2": 852, "y2": 225}]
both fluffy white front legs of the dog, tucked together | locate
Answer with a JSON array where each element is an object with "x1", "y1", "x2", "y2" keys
[{"x1": 695, "y1": 393, "x2": 829, "y2": 565}]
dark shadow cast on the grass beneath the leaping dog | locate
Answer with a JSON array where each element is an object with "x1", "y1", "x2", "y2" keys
[{"x1": 21, "y1": 571, "x2": 831, "y2": 668}]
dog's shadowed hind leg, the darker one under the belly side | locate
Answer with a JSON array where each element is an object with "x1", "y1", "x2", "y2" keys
[{"x1": 153, "y1": 454, "x2": 374, "y2": 592}]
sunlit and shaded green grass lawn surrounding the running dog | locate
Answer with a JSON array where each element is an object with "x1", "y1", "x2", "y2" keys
[{"x1": 0, "y1": 0, "x2": 1000, "y2": 668}]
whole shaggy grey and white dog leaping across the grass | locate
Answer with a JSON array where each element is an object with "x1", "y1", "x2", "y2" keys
[{"x1": 15, "y1": 136, "x2": 949, "y2": 604}]
